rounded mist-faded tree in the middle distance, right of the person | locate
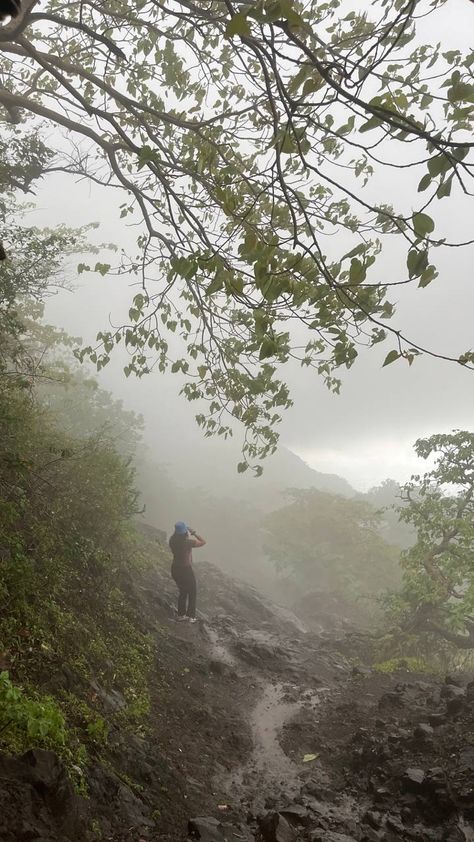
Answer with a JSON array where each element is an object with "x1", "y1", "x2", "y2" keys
[{"x1": 265, "y1": 490, "x2": 398, "y2": 599}]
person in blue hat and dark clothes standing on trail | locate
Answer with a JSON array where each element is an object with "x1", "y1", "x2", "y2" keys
[{"x1": 169, "y1": 520, "x2": 206, "y2": 623}]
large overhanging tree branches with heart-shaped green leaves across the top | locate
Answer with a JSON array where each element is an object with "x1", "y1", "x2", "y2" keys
[{"x1": 0, "y1": 0, "x2": 474, "y2": 471}]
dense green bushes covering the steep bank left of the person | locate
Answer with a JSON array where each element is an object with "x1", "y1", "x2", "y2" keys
[{"x1": 0, "y1": 260, "x2": 153, "y2": 786}]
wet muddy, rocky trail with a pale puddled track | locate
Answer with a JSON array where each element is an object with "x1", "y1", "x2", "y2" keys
[{"x1": 0, "y1": 548, "x2": 474, "y2": 842}]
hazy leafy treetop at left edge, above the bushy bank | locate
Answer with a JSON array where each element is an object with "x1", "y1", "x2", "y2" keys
[{"x1": 0, "y1": 128, "x2": 98, "y2": 387}]
